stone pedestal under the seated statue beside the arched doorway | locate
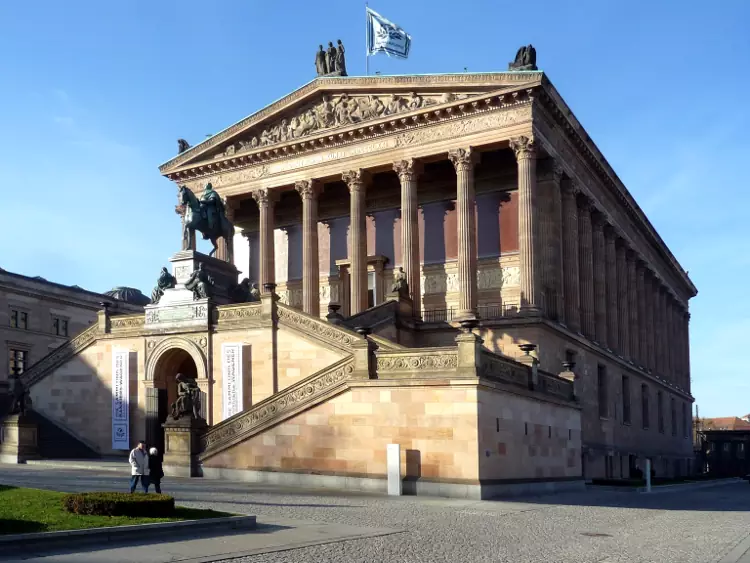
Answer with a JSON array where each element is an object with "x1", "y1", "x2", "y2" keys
[{"x1": 163, "y1": 416, "x2": 208, "y2": 477}]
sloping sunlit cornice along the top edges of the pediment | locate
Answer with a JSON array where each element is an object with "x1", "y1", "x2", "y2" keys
[{"x1": 159, "y1": 72, "x2": 543, "y2": 175}]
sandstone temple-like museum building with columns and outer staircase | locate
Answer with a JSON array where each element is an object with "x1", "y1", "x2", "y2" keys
[{"x1": 10, "y1": 62, "x2": 697, "y2": 498}]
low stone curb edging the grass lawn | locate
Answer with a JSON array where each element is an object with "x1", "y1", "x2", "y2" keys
[{"x1": 0, "y1": 516, "x2": 256, "y2": 556}]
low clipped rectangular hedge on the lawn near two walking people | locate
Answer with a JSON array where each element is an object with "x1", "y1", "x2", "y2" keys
[{"x1": 62, "y1": 493, "x2": 175, "y2": 518}]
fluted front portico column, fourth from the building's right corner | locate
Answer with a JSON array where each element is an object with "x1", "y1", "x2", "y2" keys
[{"x1": 341, "y1": 168, "x2": 367, "y2": 315}]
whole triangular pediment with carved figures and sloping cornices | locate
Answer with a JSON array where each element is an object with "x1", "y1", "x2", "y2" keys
[{"x1": 160, "y1": 72, "x2": 542, "y2": 175}]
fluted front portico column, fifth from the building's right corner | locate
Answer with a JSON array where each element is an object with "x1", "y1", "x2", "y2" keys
[{"x1": 294, "y1": 180, "x2": 321, "y2": 317}]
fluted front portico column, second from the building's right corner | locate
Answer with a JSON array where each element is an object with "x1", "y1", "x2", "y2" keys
[{"x1": 448, "y1": 148, "x2": 482, "y2": 319}]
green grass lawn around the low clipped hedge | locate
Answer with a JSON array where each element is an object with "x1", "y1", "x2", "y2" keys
[{"x1": 0, "y1": 485, "x2": 232, "y2": 534}]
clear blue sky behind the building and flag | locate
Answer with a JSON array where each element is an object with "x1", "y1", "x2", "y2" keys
[{"x1": 0, "y1": 0, "x2": 750, "y2": 416}]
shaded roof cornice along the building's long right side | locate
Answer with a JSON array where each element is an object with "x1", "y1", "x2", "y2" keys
[{"x1": 538, "y1": 76, "x2": 698, "y2": 297}]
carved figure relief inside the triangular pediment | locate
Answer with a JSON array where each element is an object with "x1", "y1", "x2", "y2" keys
[{"x1": 214, "y1": 92, "x2": 482, "y2": 158}]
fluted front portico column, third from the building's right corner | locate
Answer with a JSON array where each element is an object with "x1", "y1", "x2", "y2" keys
[{"x1": 393, "y1": 158, "x2": 422, "y2": 317}]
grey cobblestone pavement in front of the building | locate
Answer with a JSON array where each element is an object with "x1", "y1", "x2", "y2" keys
[{"x1": 0, "y1": 466, "x2": 750, "y2": 563}]
